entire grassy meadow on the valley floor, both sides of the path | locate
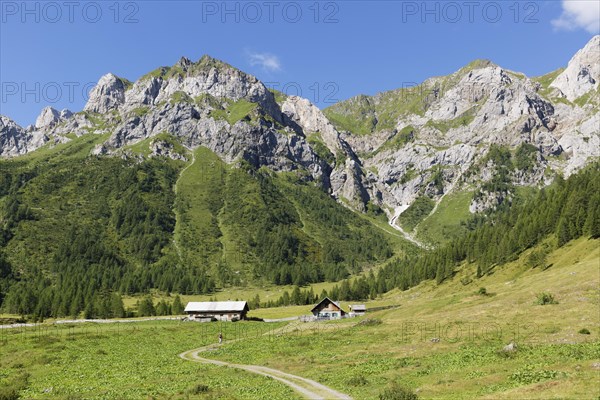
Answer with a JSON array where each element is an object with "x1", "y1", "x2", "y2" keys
[{"x1": 0, "y1": 239, "x2": 600, "y2": 399}]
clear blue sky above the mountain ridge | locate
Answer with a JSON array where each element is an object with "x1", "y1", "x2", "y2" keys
[{"x1": 0, "y1": 0, "x2": 600, "y2": 125}]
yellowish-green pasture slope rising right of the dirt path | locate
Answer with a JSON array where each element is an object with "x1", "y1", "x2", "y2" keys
[{"x1": 211, "y1": 239, "x2": 600, "y2": 399}]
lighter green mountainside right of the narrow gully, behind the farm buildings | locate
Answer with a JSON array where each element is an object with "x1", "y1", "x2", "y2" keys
[{"x1": 175, "y1": 149, "x2": 398, "y2": 285}]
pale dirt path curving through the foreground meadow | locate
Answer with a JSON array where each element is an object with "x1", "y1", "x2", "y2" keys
[{"x1": 179, "y1": 341, "x2": 352, "y2": 400}]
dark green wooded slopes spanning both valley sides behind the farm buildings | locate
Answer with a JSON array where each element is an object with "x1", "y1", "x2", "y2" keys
[{"x1": 0, "y1": 133, "x2": 600, "y2": 319}]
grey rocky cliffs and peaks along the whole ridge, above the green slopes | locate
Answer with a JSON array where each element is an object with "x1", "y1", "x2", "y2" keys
[{"x1": 0, "y1": 36, "x2": 600, "y2": 222}]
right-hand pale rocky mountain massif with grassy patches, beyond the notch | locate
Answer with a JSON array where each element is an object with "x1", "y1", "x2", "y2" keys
[{"x1": 324, "y1": 36, "x2": 600, "y2": 242}]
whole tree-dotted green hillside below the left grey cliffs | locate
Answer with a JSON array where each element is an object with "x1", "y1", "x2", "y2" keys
[{"x1": 0, "y1": 134, "x2": 398, "y2": 318}]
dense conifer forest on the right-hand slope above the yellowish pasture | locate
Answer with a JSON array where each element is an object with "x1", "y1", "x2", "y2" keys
[{"x1": 380, "y1": 163, "x2": 600, "y2": 289}]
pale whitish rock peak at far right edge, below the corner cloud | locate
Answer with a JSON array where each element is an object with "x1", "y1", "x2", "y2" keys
[{"x1": 550, "y1": 35, "x2": 600, "y2": 101}]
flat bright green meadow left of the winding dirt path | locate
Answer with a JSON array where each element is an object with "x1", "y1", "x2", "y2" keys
[{"x1": 0, "y1": 321, "x2": 299, "y2": 400}]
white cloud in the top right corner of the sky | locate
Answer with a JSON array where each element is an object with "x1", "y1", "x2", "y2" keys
[{"x1": 552, "y1": 0, "x2": 600, "y2": 34}]
